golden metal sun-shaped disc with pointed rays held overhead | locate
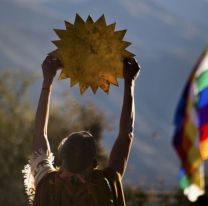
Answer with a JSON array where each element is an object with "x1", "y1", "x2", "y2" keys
[{"x1": 50, "y1": 14, "x2": 135, "y2": 94}]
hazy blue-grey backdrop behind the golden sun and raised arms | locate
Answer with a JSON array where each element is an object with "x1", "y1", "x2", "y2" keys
[{"x1": 0, "y1": 0, "x2": 208, "y2": 190}]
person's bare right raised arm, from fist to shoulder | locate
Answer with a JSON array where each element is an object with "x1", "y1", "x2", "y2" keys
[{"x1": 109, "y1": 58, "x2": 140, "y2": 177}]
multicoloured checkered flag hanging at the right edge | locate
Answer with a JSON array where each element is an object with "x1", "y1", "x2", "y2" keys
[{"x1": 173, "y1": 49, "x2": 208, "y2": 202}]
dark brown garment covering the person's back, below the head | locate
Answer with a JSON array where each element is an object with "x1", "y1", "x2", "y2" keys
[{"x1": 33, "y1": 168, "x2": 125, "y2": 206}]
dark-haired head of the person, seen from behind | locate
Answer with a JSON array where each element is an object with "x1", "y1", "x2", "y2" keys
[{"x1": 58, "y1": 131, "x2": 96, "y2": 173}]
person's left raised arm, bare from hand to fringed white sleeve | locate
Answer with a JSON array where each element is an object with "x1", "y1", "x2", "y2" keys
[{"x1": 32, "y1": 56, "x2": 61, "y2": 153}]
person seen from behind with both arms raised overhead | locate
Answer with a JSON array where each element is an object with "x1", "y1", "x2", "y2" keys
[{"x1": 23, "y1": 56, "x2": 140, "y2": 206}]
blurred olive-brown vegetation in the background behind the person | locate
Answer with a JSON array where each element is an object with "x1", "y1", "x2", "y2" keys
[{"x1": 0, "y1": 70, "x2": 206, "y2": 206}]
